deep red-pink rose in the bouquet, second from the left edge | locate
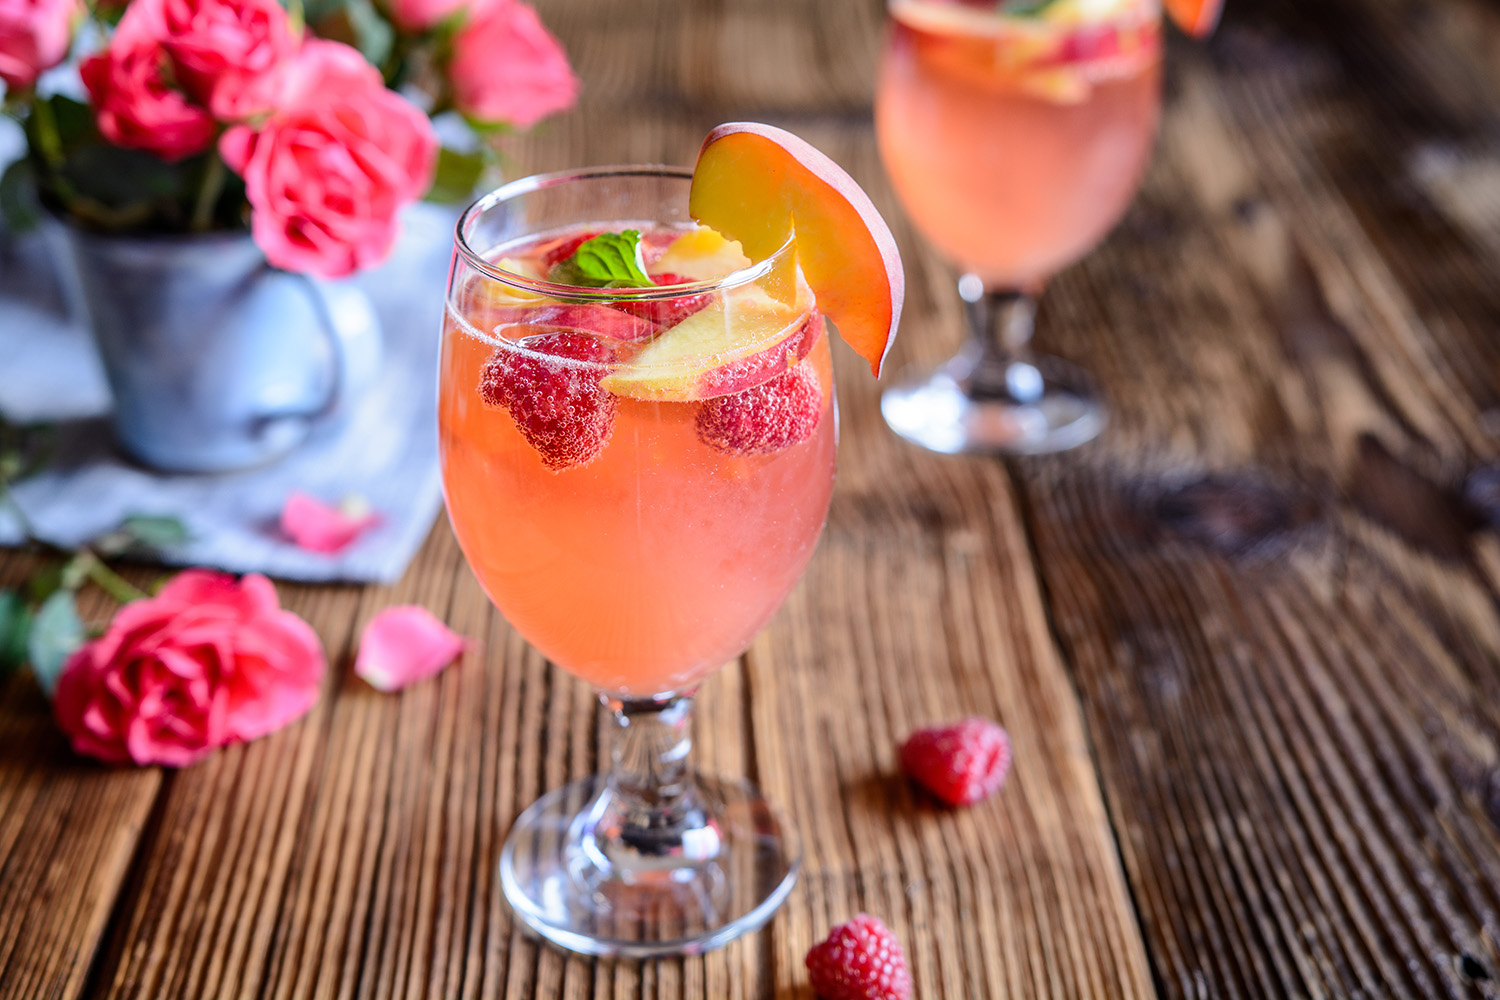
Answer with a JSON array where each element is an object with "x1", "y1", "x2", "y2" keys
[{"x1": 78, "y1": 4, "x2": 218, "y2": 160}]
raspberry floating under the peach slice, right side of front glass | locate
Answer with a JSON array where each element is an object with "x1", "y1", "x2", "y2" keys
[{"x1": 698, "y1": 363, "x2": 824, "y2": 454}]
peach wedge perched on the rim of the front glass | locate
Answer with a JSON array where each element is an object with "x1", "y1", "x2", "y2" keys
[{"x1": 689, "y1": 121, "x2": 906, "y2": 378}]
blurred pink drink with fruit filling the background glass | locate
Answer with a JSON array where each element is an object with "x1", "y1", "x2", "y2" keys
[{"x1": 876, "y1": 0, "x2": 1161, "y2": 289}]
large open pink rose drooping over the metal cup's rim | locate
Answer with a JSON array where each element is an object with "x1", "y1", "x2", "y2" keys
[{"x1": 219, "y1": 39, "x2": 438, "y2": 277}]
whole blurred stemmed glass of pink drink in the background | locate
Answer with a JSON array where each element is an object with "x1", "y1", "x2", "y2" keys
[{"x1": 876, "y1": 0, "x2": 1161, "y2": 454}]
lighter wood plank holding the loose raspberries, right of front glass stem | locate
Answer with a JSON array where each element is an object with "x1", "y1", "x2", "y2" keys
[{"x1": 732, "y1": 122, "x2": 1154, "y2": 997}]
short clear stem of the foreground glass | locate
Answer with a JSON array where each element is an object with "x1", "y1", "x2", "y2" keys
[{"x1": 594, "y1": 691, "x2": 719, "y2": 871}]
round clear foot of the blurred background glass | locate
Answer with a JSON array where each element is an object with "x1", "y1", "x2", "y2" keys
[{"x1": 881, "y1": 349, "x2": 1106, "y2": 454}]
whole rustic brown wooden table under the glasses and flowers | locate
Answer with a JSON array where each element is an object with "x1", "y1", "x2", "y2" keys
[{"x1": 0, "y1": 0, "x2": 1500, "y2": 1000}]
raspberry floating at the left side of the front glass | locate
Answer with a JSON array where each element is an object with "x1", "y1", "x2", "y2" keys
[{"x1": 479, "y1": 333, "x2": 620, "y2": 472}]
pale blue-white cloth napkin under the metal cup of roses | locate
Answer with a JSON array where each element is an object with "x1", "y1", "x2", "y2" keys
[{"x1": 0, "y1": 185, "x2": 456, "y2": 583}]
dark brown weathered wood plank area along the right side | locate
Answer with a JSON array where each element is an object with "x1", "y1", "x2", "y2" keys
[{"x1": 1014, "y1": 3, "x2": 1500, "y2": 997}]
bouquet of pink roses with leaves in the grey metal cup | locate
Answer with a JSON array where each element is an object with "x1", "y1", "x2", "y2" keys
[{"x1": 0, "y1": 0, "x2": 579, "y2": 277}]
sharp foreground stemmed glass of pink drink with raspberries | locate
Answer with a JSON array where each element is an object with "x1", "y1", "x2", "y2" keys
[{"x1": 440, "y1": 166, "x2": 837, "y2": 958}]
